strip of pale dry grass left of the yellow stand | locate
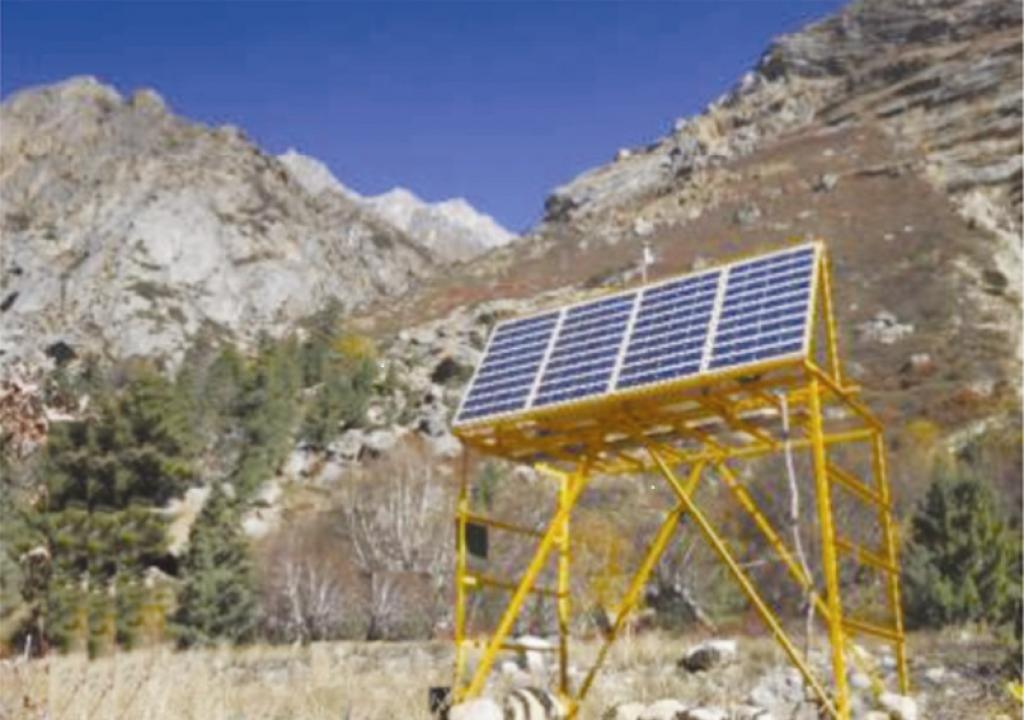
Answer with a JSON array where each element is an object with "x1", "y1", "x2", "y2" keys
[{"x1": 0, "y1": 643, "x2": 451, "y2": 720}]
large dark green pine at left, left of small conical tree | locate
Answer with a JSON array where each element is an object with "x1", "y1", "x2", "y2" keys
[{"x1": 39, "y1": 366, "x2": 195, "y2": 652}]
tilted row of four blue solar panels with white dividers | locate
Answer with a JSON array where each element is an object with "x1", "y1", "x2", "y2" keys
[{"x1": 456, "y1": 245, "x2": 818, "y2": 425}]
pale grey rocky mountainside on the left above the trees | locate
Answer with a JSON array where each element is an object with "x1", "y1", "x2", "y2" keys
[{"x1": 0, "y1": 78, "x2": 436, "y2": 364}]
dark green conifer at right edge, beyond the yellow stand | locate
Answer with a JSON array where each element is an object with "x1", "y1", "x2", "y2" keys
[{"x1": 903, "y1": 467, "x2": 1020, "y2": 627}]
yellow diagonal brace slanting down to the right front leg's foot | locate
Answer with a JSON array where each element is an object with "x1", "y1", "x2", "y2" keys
[{"x1": 647, "y1": 448, "x2": 849, "y2": 720}]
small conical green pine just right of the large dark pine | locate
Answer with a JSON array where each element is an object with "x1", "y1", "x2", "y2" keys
[{"x1": 174, "y1": 485, "x2": 257, "y2": 646}]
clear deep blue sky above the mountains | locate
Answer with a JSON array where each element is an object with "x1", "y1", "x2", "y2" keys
[{"x1": 0, "y1": 0, "x2": 844, "y2": 230}]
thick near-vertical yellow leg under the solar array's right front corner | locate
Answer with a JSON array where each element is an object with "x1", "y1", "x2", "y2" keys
[{"x1": 808, "y1": 377, "x2": 850, "y2": 720}]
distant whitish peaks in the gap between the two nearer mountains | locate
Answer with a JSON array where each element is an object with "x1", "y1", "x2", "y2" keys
[{"x1": 279, "y1": 150, "x2": 515, "y2": 261}]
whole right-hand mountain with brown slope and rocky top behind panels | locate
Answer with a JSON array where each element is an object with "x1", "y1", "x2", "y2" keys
[{"x1": 364, "y1": 0, "x2": 1022, "y2": 436}]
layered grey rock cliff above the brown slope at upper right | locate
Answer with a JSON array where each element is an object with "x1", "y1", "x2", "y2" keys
[{"x1": 547, "y1": 0, "x2": 1021, "y2": 232}]
